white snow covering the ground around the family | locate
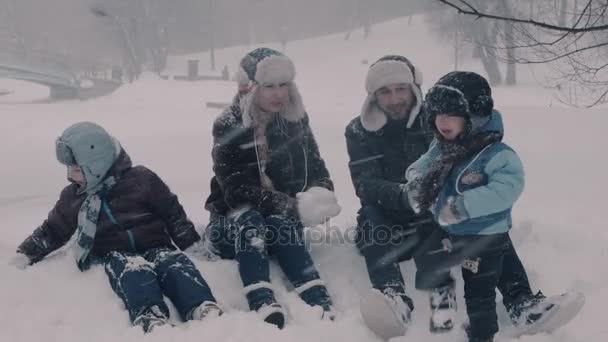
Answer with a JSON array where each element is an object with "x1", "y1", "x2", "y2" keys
[{"x1": 0, "y1": 17, "x2": 608, "y2": 342}]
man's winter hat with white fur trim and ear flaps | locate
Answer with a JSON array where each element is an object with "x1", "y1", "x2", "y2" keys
[{"x1": 361, "y1": 55, "x2": 422, "y2": 132}]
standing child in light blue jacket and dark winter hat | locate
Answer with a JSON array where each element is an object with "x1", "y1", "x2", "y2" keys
[{"x1": 406, "y1": 71, "x2": 584, "y2": 342}]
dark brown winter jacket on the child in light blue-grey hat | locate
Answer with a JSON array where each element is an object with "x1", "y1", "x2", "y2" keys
[{"x1": 18, "y1": 150, "x2": 200, "y2": 262}]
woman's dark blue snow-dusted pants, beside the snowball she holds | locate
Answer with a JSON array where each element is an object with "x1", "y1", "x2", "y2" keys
[{"x1": 204, "y1": 210, "x2": 331, "y2": 311}]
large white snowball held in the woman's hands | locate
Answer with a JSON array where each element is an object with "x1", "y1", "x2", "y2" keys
[{"x1": 296, "y1": 187, "x2": 342, "y2": 227}]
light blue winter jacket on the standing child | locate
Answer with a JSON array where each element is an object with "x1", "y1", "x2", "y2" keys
[{"x1": 406, "y1": 111, "x2": 524, "y2": 235}]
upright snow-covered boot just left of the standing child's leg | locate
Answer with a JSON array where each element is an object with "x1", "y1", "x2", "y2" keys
[{"x1": 429, "y1": 284, "x2": 456, "y2": 333}]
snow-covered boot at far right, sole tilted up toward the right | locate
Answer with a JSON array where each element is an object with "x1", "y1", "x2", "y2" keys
[{"x1": 508, "y1": 291, "x2": 585, "y2": 336}]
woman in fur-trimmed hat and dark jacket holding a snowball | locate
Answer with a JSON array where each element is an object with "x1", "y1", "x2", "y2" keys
[{"x1": 204, "y1": 48, "x2": 340, "y2": 328}]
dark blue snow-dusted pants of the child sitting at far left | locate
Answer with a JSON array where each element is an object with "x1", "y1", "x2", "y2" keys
[{"x1": 104, "y1": 248, "x2": 215, "y2": 322}]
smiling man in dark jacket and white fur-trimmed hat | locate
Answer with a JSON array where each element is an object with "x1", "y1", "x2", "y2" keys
[{"x1": 345, "y1": 55, "x2": 455, "y2": 337}]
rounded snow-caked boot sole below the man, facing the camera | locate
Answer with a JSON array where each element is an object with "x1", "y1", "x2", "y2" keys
[{"x1": 360, "y1": 288, "x2": 414, "y2": 340}]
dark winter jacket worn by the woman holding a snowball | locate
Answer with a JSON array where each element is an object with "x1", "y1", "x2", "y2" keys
[{"x1": 205, "y1": 101, "x2": 333, "y2": 217}]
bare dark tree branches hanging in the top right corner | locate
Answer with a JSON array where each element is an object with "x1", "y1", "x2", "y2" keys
[{"x1": 436, "y1": 0, "x2": 608, "y2": 107}]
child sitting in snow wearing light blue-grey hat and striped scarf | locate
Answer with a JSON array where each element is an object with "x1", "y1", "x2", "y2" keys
[{"x1": 15, "y1": 122, "x2": 222, "y2": 332}]
